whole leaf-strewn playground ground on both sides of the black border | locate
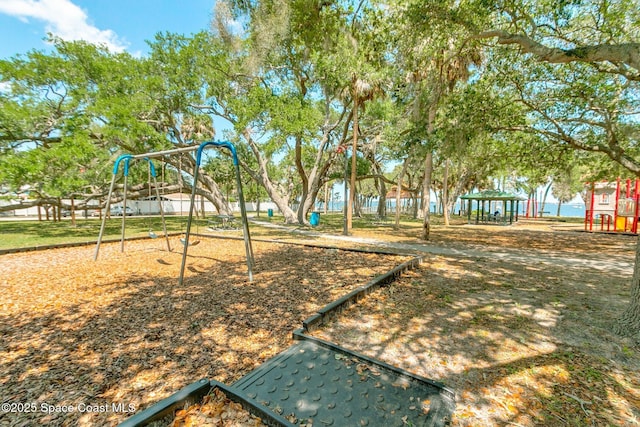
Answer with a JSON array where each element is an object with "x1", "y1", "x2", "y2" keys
[{"x1": 0, "y1": 221, "x2": 640, "y2": 426}]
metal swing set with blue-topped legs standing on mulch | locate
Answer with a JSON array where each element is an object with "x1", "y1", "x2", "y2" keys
[{"x1": 93, "y1": 141, "x2": 255, "y2": 285}]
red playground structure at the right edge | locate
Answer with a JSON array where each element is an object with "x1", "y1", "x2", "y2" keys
[{"x1": 584, "y1": 178, "x2": 640, "y2": 233}]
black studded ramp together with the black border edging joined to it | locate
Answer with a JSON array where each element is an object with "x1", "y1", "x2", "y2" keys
[{"x1": 116, "y1": 257, "x2": 455, "y2": 427}]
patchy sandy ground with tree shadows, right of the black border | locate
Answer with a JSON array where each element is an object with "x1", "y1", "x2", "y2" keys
[{"x1": 314, "y1": 226, "x2": 640, "y2": 427}]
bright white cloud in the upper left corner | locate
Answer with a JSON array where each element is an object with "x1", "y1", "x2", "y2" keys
[{"x1": 0, "y1": 0, "x2": 127, "y2": 52}]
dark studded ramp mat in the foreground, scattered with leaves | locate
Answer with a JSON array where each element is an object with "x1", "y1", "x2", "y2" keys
[{"x1": 232, "y1": 335, "x2": 455, "y2": 427}]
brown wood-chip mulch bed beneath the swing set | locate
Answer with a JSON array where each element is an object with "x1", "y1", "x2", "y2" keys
[{"x1": 0, "y1": 238, "x2": 407, "y2": 426}]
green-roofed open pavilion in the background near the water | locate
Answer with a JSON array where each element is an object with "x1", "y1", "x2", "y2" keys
[{"x1": 460, "y1": 190, "x2": 525, "y2": 225}]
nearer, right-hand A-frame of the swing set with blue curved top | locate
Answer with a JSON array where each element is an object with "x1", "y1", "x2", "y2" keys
[{"x1": 178, "y1": 141, "x2": 255, "y2": 285}]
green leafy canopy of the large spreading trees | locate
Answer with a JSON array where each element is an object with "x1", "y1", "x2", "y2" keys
[{"x1": 0, "y1": 0, "x2": 640, "y2": 222}]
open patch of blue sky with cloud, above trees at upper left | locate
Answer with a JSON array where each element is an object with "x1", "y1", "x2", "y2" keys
[{"x1": 0, "y1": 0, "x2": 215, "y2": 59}]
